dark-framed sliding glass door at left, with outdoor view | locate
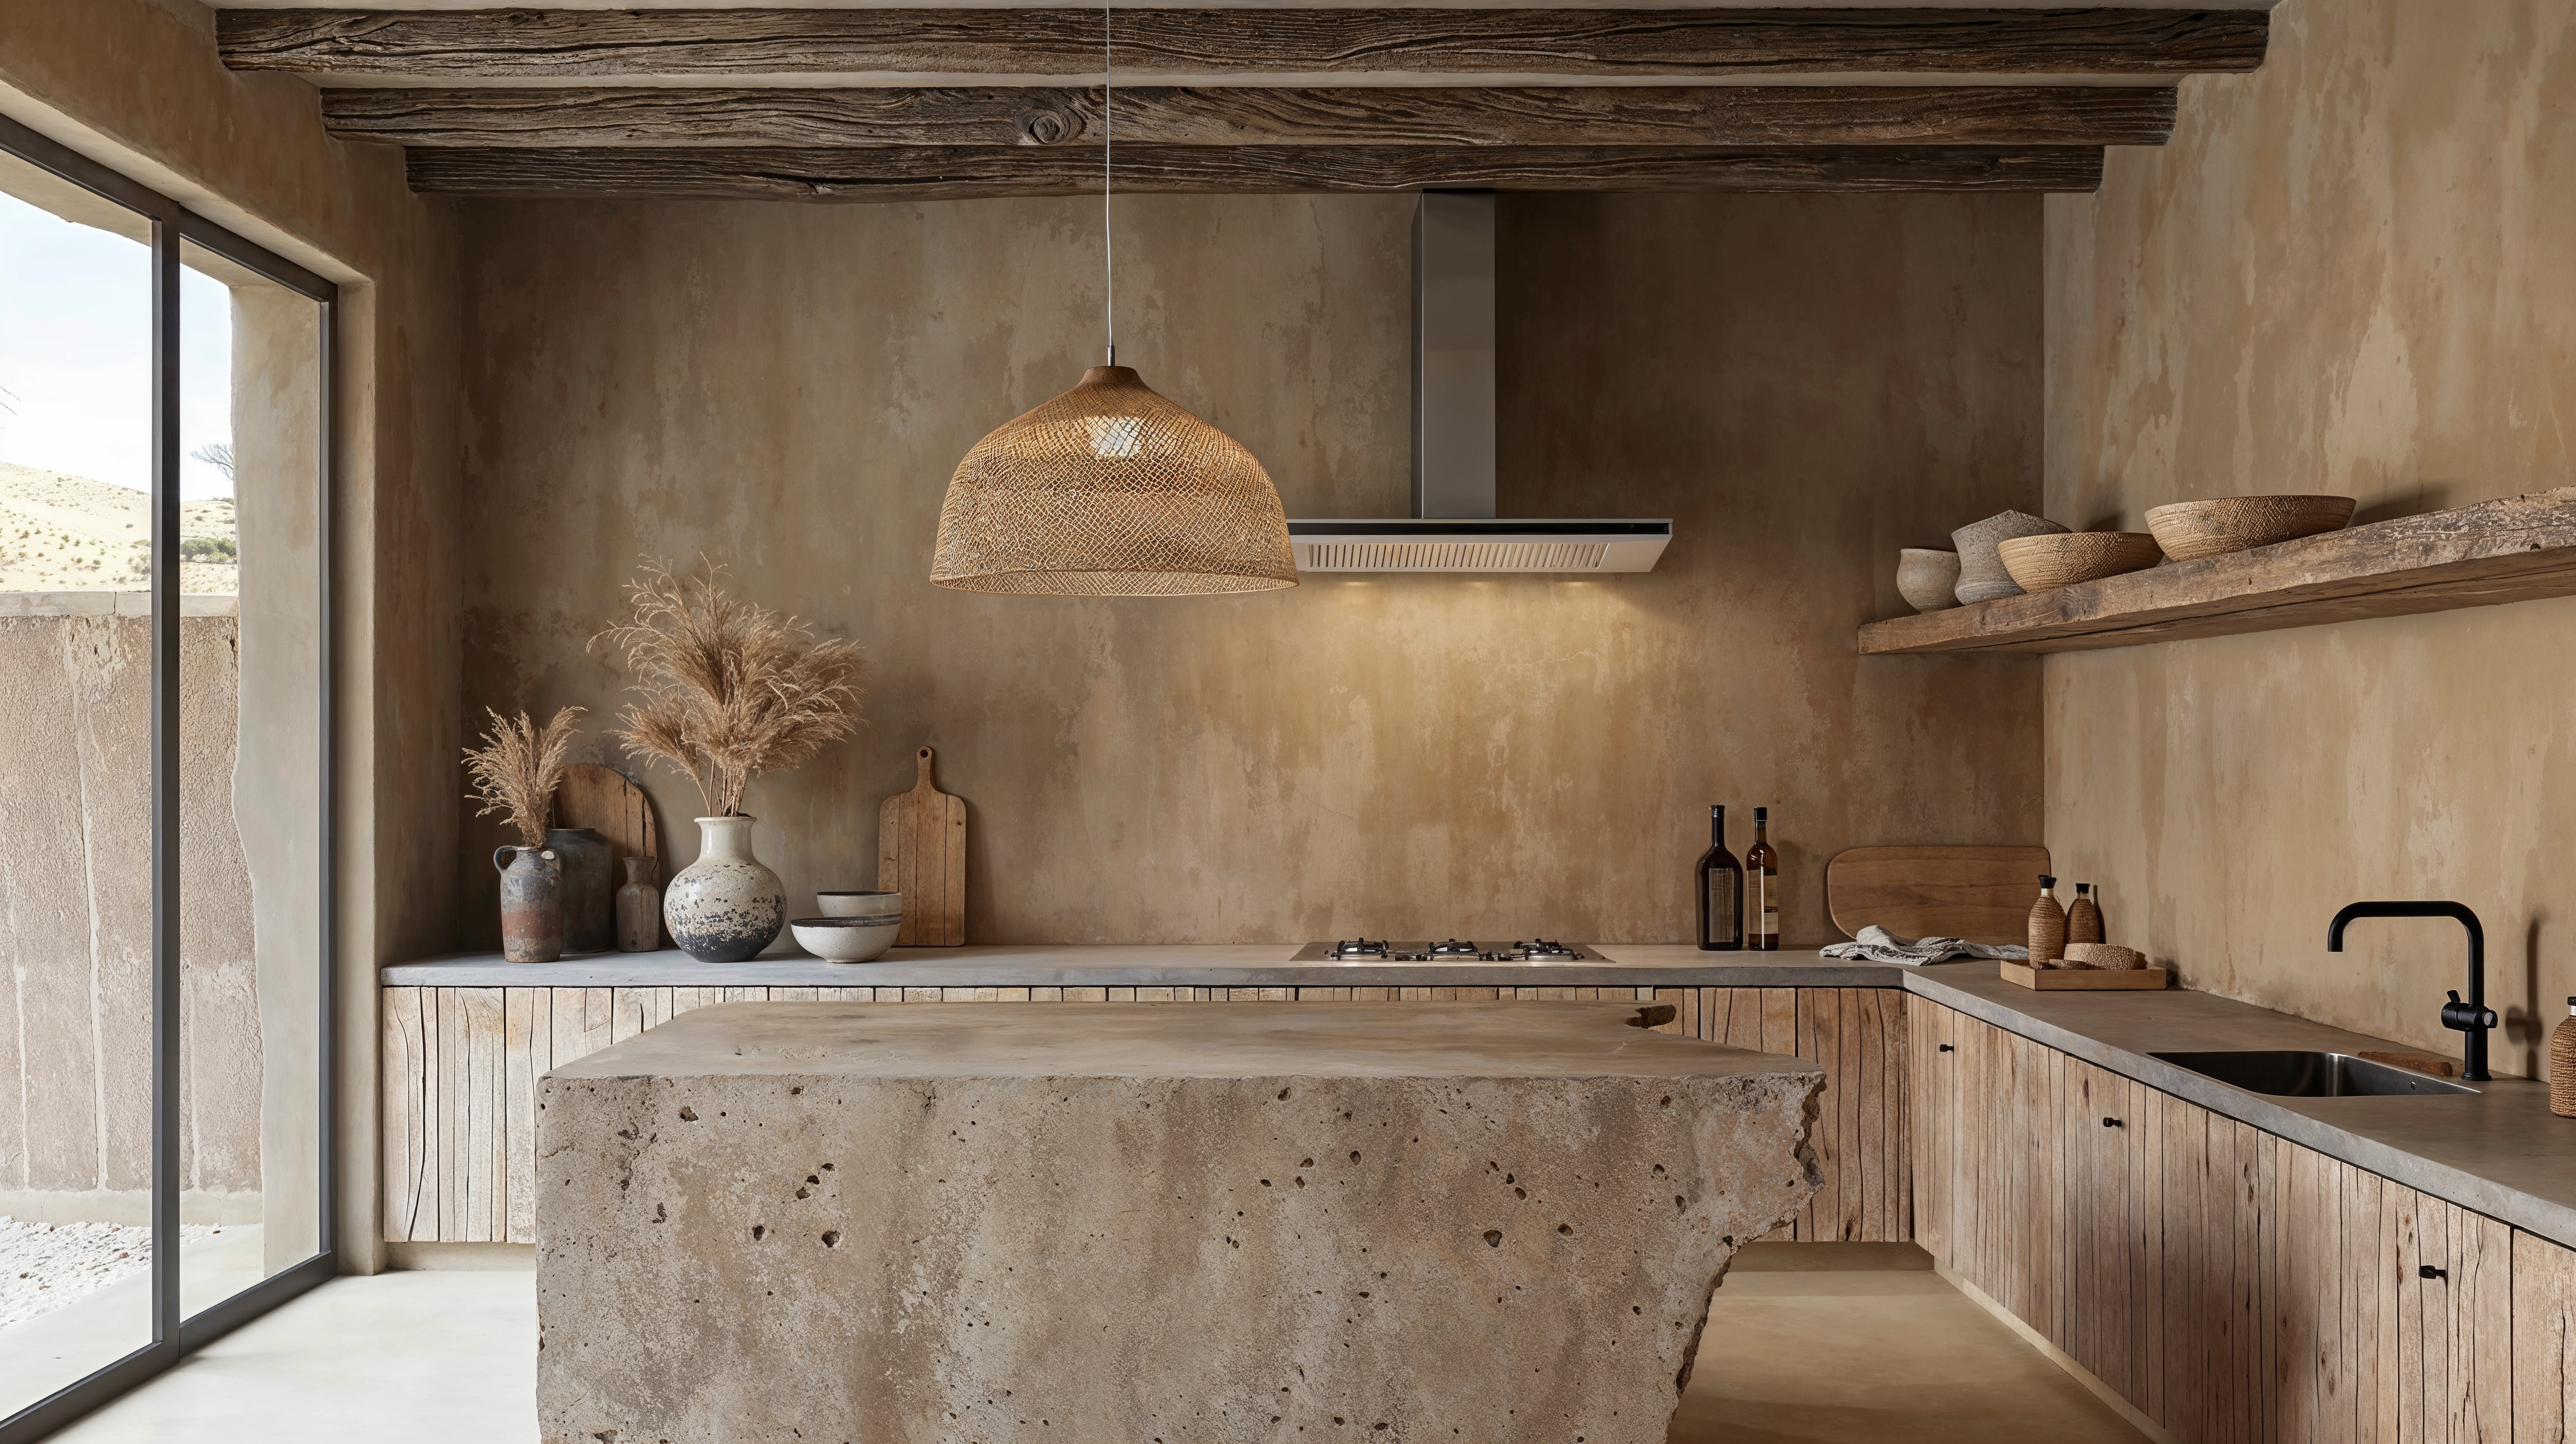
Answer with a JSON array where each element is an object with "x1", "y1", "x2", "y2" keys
[{"x1": 0, "y1": 121, "x2": 337, "y2": 1444}]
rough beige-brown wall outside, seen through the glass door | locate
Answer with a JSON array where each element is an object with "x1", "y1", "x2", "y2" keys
[{"x1": 0, "y1": 598, "x2": 260, "y2": 1222}]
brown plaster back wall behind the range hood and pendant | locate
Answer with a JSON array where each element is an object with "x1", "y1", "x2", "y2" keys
[{"x1": 453, "y1": 185, "x2": 2040, "y2": 941}]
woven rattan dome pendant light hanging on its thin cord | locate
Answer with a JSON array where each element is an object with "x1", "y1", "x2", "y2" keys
[{"x1": 930, "y1": 10, "x2": 1296, "y2": 595}]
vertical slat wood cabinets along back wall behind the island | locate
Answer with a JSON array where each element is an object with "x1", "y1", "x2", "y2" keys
[{"x1": 381, "y1": 987, "x2": 1914, "y2": 1243}]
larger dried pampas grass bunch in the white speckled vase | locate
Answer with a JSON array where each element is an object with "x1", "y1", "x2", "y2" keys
[{"x1": 590, "y1": 562, "x2": 866, "y2": 818}]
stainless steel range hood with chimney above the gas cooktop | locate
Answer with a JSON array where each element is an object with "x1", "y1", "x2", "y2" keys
[{"x1": 1288, "y1": 191, "x2": 1672, "y2": 575}]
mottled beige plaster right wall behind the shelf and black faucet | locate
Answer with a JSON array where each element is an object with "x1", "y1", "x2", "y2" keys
[{"x1": 2045, "y1": 0, "x2": 2576, "y2": 1070}]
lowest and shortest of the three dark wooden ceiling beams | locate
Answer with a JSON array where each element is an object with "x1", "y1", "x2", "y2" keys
[{"x1": 410, "y1": 144, "x2": 2102, "y2": 201}]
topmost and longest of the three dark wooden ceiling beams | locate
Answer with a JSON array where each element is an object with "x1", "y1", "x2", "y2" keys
[{"x1": 216, "y1": 8, "x2": 2269, "y2": 77}]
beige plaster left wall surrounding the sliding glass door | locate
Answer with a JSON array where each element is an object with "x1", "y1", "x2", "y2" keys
[{"x1": 0, "y1": 0, "x2": 459, "y2": 1269}]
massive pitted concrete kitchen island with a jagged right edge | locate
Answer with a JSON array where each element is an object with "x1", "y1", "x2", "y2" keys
[{"x1": 536, "y1": 1003, "x2": 1824, "y2": 1444}]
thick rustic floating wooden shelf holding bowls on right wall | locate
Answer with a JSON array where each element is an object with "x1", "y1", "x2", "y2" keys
[{"x1": 1860, "y1": 488, "x2": 2576, "y2": 655}]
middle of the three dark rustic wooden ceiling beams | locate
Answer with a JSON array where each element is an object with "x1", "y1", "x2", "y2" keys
[{"x1": 322, "y1": 85, "x2": 2174, "y2": 147}]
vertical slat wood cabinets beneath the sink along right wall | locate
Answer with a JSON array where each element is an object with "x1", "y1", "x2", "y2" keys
[{"x1": 1909, "y1": 998, "x2": 2534, "y2": 1444}]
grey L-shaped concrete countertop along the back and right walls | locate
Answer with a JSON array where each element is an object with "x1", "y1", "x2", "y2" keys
[{"x1": 381, "y1": 944, "x2": 2576, "y2": 1248}]
